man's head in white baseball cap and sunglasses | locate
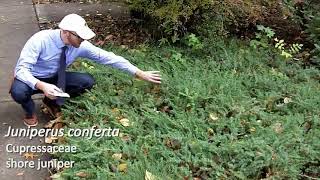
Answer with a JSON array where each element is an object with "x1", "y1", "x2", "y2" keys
[{"x1": 59, "y1": 14, "x2": 95, "y2": 48}]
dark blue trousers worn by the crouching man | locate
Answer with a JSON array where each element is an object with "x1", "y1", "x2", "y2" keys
[{"x1": 10, "y1": 72, "x2": 94, "y2": 116}]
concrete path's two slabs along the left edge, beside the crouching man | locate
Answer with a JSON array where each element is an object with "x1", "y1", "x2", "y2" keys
[{"x1": 0, "y1": 0, "x2": 49, "y2": 180}]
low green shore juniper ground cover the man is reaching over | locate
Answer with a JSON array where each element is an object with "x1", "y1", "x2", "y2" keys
[{"x1": 53, "y1": 39, "x2": 320, "y2": 179}]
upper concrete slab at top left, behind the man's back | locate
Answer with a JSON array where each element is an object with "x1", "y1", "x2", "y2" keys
[{"x1": 0, "y1": 0, "x2": 39, "y2": 101}]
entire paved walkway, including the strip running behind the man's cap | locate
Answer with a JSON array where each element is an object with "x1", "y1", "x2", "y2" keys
[{"x1": 0, "y1": 0, "x2": 128, "y2": 180}]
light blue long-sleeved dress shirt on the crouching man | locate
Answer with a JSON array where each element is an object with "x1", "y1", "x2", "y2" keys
[{"x1": 14, "y1": 29, "x2": 138, "y2": 89}]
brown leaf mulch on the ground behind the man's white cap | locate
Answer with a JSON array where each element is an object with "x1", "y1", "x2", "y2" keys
[{"x1": 34, "y1": 0, "x2": 151, "y2": 47}]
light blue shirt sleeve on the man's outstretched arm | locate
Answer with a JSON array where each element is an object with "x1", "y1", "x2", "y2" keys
[{"x1": 79, "y1": 41, "x2": 138, "y2": 75}]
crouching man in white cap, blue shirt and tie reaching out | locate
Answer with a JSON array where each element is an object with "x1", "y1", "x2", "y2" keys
[{"x1": 10, "y1": 14, "x2": 161, "y2": 126}]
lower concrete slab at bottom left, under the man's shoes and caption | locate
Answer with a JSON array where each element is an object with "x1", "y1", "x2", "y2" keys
[{"x1": 0, "y1": 101, "x2": 50, "y2": 180}]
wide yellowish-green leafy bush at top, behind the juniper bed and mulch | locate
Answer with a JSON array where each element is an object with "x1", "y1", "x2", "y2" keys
[{"x1": 129, "y1": 0, "x2": 300, "y2": 42}]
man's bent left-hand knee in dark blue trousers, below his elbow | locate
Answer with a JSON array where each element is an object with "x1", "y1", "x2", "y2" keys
[{"x1": 10, "y1": 79, "x2": 32, "y2": 103}]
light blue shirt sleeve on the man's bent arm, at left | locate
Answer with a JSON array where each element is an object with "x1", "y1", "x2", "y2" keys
[{"x1": 14, "y1": 36, "x2": 41, "y2": 90}]
